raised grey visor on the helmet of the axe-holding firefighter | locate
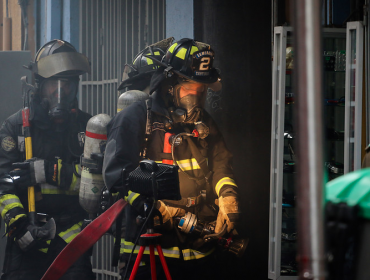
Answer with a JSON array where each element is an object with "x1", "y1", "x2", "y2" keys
[{"x1": 36, "y1": 52, "x2": 90, "y2": 78}]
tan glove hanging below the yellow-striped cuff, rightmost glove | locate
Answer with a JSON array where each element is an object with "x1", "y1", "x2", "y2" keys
[{"x1": 215, "y1": 195, "x2": 240, "y2": 233}]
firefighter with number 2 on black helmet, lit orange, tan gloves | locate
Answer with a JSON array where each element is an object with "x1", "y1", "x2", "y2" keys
[{"x1": 103, "y1": 39, "x2": 239, "y2": 279}]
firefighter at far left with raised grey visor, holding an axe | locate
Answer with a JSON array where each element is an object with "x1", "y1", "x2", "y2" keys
[{"x1": 0, "y1": 40, "x2": 94, "y2": 280}]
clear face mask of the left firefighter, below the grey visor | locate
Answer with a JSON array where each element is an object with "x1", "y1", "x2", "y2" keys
[{"x1": 40, "y1": 77, "x2": 78, "y2": 124}]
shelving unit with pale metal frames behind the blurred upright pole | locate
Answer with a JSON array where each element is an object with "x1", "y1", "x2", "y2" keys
[{"x1": 268, "y1": 22, "x2": 363, "y2": 280}]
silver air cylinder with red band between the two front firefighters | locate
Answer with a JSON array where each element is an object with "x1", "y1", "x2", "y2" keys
[{"x1": 79, "y1": 114, "x2": 111, "y2": 214}]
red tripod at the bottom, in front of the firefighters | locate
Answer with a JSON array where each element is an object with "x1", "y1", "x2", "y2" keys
[{"x1": 130, "y1": 229, "x2": 172, "y2": 280}]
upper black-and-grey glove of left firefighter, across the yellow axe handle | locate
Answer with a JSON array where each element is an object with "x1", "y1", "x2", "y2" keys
[{"x1": 9, "y1": 158, "x2": 58, "y2": 190}]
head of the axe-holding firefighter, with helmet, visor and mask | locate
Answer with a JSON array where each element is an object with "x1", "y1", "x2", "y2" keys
[{"x1": 24, "y1": 40, "x2": 90, "y2": 131}]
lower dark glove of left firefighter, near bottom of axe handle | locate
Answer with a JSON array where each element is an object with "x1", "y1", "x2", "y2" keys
[{"x1": 12, "y1": 218, "x2": 56, "y2": 251}]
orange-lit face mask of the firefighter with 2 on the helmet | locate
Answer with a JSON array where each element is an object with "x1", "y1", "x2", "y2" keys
[{"x1": 169, "y1": 78, "x2": 208, "y2": 123}]
